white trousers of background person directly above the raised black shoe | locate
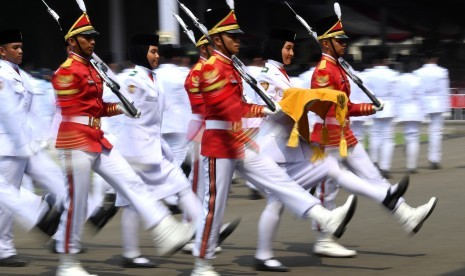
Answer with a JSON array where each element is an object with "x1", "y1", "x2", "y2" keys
[{"x1": 370, "y1": 118, "x2": 395, "y2": 171}]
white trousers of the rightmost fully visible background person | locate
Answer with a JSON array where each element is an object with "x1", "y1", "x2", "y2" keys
[{"x1": 428, "y1": 113, "x2": 444, "y2": 163}]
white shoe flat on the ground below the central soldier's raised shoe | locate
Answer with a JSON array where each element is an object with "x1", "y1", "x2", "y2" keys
[{"x1": 313, "y1": 234, "x2": 357, "y2": 258}]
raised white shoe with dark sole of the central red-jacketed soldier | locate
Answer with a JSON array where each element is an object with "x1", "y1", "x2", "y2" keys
[{"x1": 309, "y1": 195, "x2": 357, "y2": 239}]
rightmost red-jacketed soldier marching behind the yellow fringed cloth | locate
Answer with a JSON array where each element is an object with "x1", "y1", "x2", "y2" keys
[{"x1": 310, "y1": 12, "x2": 437, "y2": 257}]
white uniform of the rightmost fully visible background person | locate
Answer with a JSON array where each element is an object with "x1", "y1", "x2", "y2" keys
[{"x1": 413, "y1": 64, "x2": 450, "y2": 163}]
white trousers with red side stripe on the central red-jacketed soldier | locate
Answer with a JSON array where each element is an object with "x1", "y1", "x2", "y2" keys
[{"x1": 193, "y1": 149, "x2": 321, "y2": 259}]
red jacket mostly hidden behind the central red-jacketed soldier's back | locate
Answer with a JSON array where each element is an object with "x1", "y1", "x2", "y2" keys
[{"x1": 184, "y1": 57, "x2": 206, "y2": 142}]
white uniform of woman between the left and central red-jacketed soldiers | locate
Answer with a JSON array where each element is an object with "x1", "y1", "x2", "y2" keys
[{"x1": 115, "y1": 66, "x2": 201, "y2": 258}]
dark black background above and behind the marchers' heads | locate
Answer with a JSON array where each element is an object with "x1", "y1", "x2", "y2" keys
[{"x1": 0, "y1": 0, "x2": 465, "y2": 87}]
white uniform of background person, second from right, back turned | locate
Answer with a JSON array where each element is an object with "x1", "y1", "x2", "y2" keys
[{"x1": 396, "y1": 73, "x2": 426, "y2": 172}]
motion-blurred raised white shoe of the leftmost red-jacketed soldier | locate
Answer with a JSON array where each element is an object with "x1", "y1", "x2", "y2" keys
[{"x1": 152, "y1": 216, "x2": 195, "y2": 257}]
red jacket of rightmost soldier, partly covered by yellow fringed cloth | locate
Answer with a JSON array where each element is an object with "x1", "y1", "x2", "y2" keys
[{"x1": 310, "y1": 54, "x2": 375, "y2": 146}]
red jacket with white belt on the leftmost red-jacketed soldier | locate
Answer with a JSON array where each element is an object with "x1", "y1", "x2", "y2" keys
[{"x1": 52, "y1": 52, "x2": 120, "y2": 152}]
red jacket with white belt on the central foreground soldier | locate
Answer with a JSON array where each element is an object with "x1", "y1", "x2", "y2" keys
[{"x1": 199, "y1": 51, "x2": 264, "y2": 159}]
